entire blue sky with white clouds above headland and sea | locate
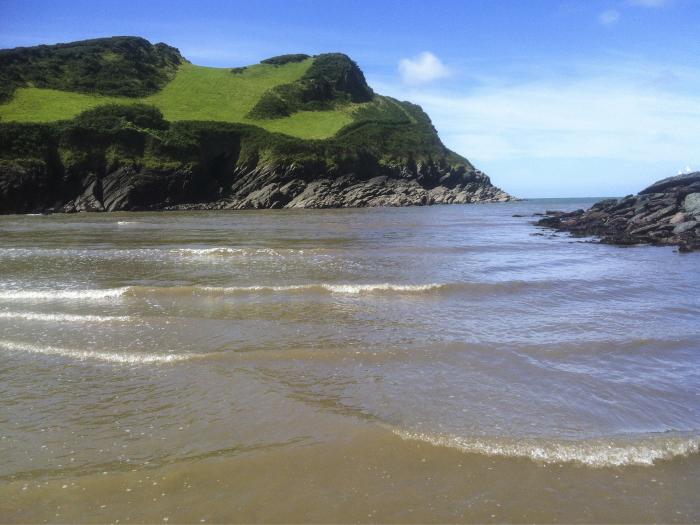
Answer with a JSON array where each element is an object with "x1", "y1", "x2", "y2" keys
[{"x1": 0, "y1": 0, "x2": 700, "y2": 198}]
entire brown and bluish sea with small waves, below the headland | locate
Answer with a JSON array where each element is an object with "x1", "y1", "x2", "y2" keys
[{"x1": 0, "y1": 200, "x2": 700, "y2": 523}]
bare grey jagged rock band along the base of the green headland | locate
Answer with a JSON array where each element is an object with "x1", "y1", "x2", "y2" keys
[{"x1": 6, "y1": 159, "x2": 511, "y2": 213}]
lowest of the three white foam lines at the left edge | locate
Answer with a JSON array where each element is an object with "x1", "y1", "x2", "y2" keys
[{"x1": 0, "y1": 340, "x2": 194, "y2": 365}]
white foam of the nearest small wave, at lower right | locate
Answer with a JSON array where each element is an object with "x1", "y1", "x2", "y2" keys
[{"x1": 392, "y1": 429, "x2": 700, "y2": 468}]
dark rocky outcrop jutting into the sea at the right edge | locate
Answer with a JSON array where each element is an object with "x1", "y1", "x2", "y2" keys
[{"x1": 537, "y1": 172, "x2": 700, "y2": 252}]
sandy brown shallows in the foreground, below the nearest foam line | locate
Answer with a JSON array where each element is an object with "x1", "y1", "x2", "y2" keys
[{"x1": 0, "y1": 423, "x2": 700, "y2": 523}]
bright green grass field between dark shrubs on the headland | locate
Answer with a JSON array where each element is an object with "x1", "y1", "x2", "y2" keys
[{"x1": 0, "y1": 59, "x2": 357, "y2": 139}]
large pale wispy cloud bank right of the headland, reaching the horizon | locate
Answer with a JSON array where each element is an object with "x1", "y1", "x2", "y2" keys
[{"x1": 370, "y1": 57, "x2": 700, "y2": 197}]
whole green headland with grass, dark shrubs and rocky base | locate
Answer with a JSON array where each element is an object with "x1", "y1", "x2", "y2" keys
[{"x1": 0, "y1": 37, "x2": 508, "y2": 213}]
